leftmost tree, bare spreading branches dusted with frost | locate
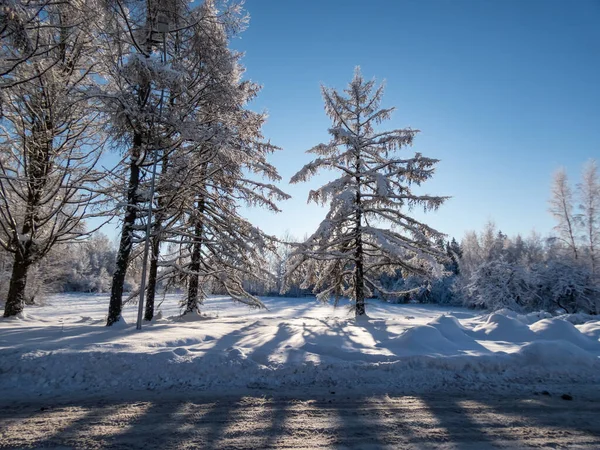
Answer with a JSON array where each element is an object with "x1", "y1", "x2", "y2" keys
[{"x1": 0, "y1": 1, "x2": 101, "y2": 316}]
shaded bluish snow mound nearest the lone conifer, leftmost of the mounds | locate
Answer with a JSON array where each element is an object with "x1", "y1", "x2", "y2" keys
[{"x1": 377, "y1": 325, "x2": 460, "y2": 355}]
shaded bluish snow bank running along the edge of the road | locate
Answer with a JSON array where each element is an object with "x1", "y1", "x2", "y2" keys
[{"x1": 0, "y1": 340, "x2": 600, "y2": 396}]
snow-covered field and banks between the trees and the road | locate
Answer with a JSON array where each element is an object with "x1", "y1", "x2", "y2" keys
[{"x1": 0, "y1": 295, "x2": 600, "y2": 398}]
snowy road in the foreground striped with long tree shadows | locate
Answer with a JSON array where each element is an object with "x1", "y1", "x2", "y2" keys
[{"x1": 0, "y1": 392, "x2": 600, "y2": 450}]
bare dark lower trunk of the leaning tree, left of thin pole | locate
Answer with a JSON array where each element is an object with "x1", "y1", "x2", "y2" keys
[{"x1": 106, "y1": 139, "x2": 142, "y2": 326}]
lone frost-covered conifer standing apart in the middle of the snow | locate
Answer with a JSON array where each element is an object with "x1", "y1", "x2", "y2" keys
[{"x1": 287, "y1": 68, "x2": 446, "y2": 316}]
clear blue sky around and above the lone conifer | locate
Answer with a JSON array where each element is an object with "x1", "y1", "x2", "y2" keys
[{"x1": 98, "y1": 0, "x2": 600, "y2": 244}]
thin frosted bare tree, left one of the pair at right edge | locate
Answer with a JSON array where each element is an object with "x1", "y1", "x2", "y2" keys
[{"x1": 550, "y1": 168, "x2": 578, "y2": 259}]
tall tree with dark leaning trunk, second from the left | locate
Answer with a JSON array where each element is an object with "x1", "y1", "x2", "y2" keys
[{"x1": 98, "y1": 0, "x2": 189, "y2": 325}]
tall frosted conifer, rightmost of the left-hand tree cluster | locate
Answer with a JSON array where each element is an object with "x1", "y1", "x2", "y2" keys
[{"x1": 126, "y1": 1, "x2": 287, "y2": 320}]
